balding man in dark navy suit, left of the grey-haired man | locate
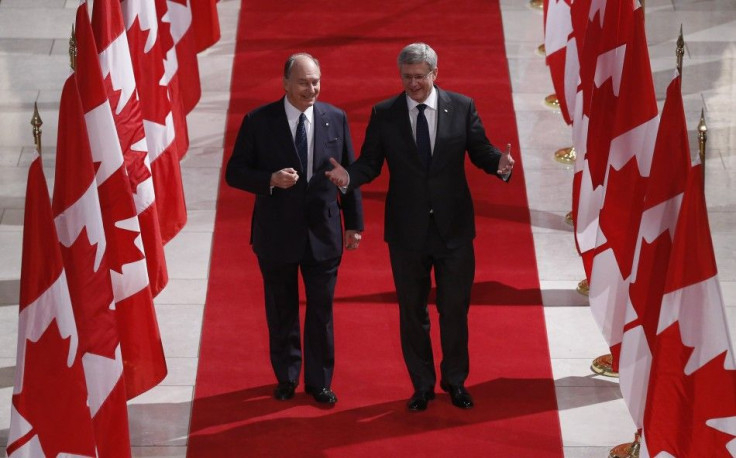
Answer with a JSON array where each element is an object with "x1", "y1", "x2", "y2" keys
[{"x1": 225, "y1": 53, "x2": 363, "y2": 404}]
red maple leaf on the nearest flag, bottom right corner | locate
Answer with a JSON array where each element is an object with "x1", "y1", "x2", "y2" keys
[{"x1": 644, "y1": 324, "x2": 736, "y2": 457}]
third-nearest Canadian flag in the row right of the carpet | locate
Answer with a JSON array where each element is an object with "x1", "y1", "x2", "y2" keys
[{"x1": 579, "y1": 0, "x2": 659, "y2": 368}]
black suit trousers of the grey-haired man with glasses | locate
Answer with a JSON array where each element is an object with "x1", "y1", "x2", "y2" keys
[{"x1": 389, "y1": 216, "x2": 475, "y2": 391}]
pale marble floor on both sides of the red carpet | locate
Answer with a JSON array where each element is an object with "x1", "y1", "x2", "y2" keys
[{"x1": 0, "y1": 0, "x2": 736, "y2": 458}]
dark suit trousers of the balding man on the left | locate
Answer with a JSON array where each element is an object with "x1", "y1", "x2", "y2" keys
[{"x1": 258, "y1": 242, "x2": 341, "y2": 388}]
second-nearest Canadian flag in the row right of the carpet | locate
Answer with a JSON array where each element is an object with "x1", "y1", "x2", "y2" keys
[{"x1": 619, "y1": 70, "x2": 690, "y2": 428}]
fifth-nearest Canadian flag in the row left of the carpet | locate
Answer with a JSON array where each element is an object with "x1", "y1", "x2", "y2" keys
[{"x1": 118, "y1": 0, "x2": 187, "y2": 243}]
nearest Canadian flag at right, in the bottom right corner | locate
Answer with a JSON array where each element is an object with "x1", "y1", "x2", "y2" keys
[{"x1": 640, "y1": 160, "x2": 736, "y2": 457}]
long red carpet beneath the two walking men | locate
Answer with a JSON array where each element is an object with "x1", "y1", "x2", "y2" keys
[{"x1": 188, "y1": 0, "x2": 562, "y2": 457}]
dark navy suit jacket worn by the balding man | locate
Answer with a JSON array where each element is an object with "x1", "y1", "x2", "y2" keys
[{"x1": 225, "y1": 98, "x2": 363, "y2": 262}]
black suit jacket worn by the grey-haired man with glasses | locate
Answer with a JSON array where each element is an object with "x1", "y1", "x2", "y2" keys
[{"x1": 348, "y1": 86, "x2": 501, "y2": 249}]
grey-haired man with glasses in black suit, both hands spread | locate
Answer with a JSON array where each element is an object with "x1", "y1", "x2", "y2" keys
[{"x1": 326, "y1": 43, "x2": 514, "y2": 411}]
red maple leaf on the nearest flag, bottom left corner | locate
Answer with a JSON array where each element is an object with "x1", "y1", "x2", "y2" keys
[{"x1": 8, "y1": 320, "x2": 95, "y2": 456}]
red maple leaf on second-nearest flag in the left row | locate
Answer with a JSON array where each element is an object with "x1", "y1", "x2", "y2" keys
[{"x1": 61, "y1": 228, "x2": 119, "y2": 359}]
